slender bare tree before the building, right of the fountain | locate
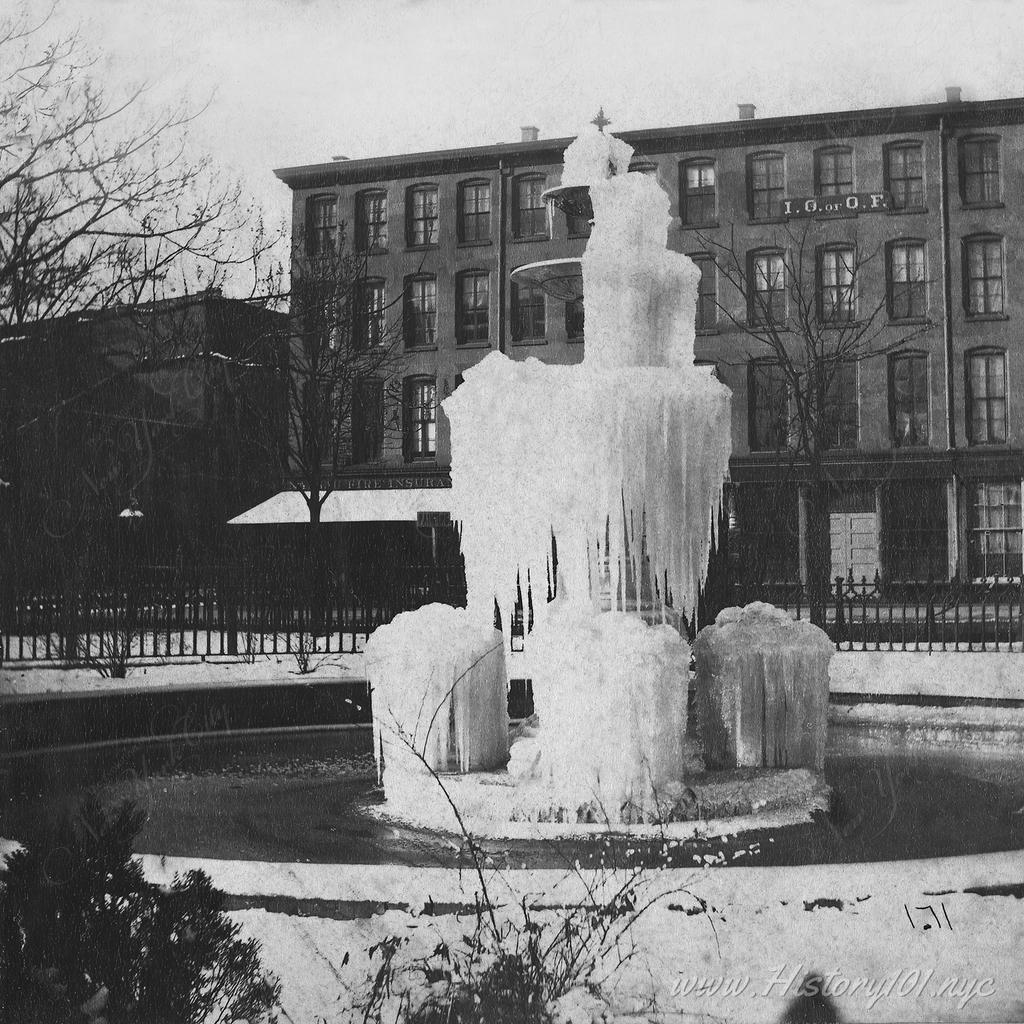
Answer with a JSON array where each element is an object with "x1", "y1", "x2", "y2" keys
[{"x1": 700, "y1": 219, "x2": 932, "y2": 625}]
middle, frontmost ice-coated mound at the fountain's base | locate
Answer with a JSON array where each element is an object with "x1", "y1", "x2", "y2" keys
[{"x1": 509, "y1": 601, "x2": 690, "y2": 821}]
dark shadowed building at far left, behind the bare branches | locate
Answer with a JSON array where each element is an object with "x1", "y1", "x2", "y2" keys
[{"x1": 0, "y1": 291, "x2": 288, "y2": 561}]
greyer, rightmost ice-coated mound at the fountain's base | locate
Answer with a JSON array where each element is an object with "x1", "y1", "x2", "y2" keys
[{"x1": 693, "y1": 601, "x2": 836, "y2": 770}]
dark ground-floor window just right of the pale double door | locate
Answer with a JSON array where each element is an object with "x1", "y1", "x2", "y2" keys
[{"x1": 882, "y1": 479, "x2": 949, "y2": 582}]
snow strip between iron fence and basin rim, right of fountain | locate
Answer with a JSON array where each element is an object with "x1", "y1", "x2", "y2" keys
[{"x1": 828, "y1": 650, "x2": 1024, "y2": 700}]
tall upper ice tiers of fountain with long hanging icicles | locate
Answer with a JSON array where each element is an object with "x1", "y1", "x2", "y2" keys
[{"x1": 443, "y1": 125, "x2": 730, "y2": 622}]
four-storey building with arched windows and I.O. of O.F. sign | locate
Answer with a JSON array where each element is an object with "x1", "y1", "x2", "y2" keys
[{"x1": 278, "y1": 89, "x2": 1024, "y2": 581}]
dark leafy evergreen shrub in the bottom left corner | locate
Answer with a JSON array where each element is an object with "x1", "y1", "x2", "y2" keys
[{"x1": 0, "y1": 797, "x2": 280, "y2": 1024}]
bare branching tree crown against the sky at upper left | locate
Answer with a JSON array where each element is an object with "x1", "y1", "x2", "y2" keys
[{"x1": 0, "y1": 5, "x2": 272, "y2": 326}]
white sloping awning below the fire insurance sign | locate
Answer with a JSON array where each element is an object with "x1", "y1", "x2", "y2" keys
[{"x1": 234, "y1": 487, "x2": 452, "y2": 526}]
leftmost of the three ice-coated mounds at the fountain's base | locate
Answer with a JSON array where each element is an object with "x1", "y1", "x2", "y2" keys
[{"x1": 364, "y1": 604, "x2": 509, "y2": 801}]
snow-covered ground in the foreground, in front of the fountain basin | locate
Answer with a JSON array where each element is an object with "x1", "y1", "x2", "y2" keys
[{"x1": 182, "y1": 853, "x2": 1024, "y2": 1022}]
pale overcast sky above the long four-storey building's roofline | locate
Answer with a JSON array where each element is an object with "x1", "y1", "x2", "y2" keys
[{"x1": 46, "y1": 0, "x2": 1024, "y2": 230}]
